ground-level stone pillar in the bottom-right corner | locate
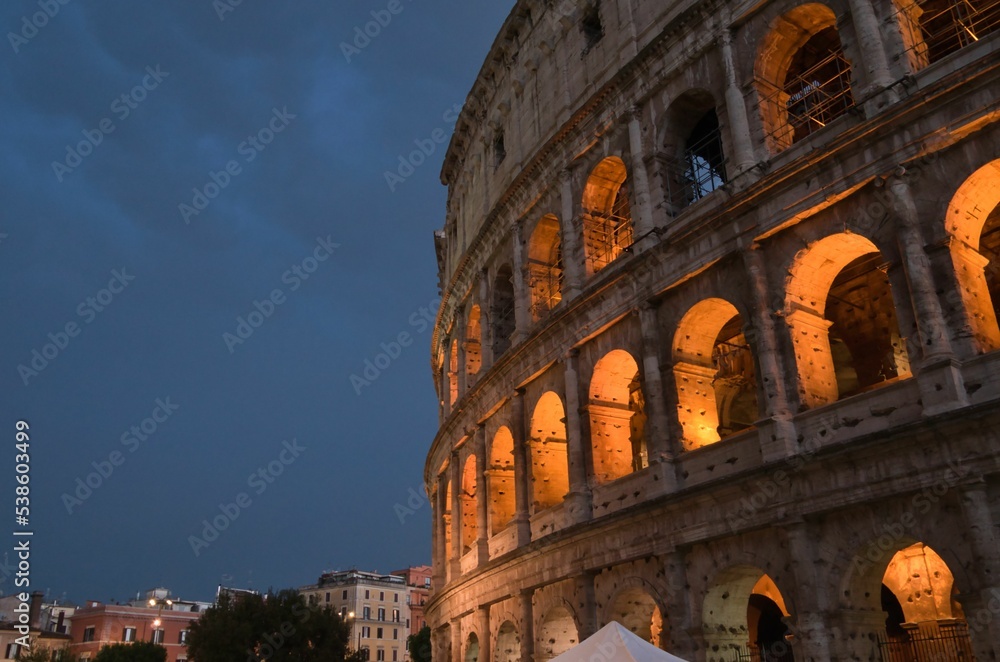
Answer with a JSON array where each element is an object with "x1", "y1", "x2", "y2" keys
[{"x1": 958, "y1": 483, "x2": 1000, "y2": 660}]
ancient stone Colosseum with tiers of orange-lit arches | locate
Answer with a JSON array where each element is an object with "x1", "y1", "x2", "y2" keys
[{"x1": 425, "y1": 0, "x2": 1000, "y2": 662}]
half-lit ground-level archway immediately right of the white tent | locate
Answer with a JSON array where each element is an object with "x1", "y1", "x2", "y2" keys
[{"x1": 702, "y1": 566, "x2": 795, "y2": 662}]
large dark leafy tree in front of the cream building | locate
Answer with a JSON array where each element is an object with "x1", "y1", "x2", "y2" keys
[{"x1": 188, "y1": 589, "x2": 362, "y2": 662}]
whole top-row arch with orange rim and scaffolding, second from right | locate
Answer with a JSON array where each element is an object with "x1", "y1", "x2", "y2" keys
[{"x1": 756, "y1": 3, "x2": 854, "y2": 151}]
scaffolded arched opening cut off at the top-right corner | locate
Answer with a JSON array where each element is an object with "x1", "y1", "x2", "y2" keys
[{"x1": 895, "y1": 0, "x2": 1000, "y2": 71}]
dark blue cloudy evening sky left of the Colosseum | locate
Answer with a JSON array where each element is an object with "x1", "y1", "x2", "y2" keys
[{"x1": 0, "y1": 0, "x2": 513, "y2": 601}]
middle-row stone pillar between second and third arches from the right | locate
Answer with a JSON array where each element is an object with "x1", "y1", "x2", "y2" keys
[{"x1": 742, "y1": 244, "x2": 796, "y2": 461}]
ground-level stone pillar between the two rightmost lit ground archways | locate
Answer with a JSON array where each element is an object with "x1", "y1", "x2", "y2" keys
[{"x1": 785, "y1": 521, "x2": 835, "y2": 660}]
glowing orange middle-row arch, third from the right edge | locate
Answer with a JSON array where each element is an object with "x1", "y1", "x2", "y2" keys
[{"x1": 673, "y1": 299, "x2": 758, "y2": 450}]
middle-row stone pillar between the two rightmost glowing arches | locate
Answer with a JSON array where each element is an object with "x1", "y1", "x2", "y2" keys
[{"x1": 890, "y1": 177, "x2": 969, "y2": 416}]
